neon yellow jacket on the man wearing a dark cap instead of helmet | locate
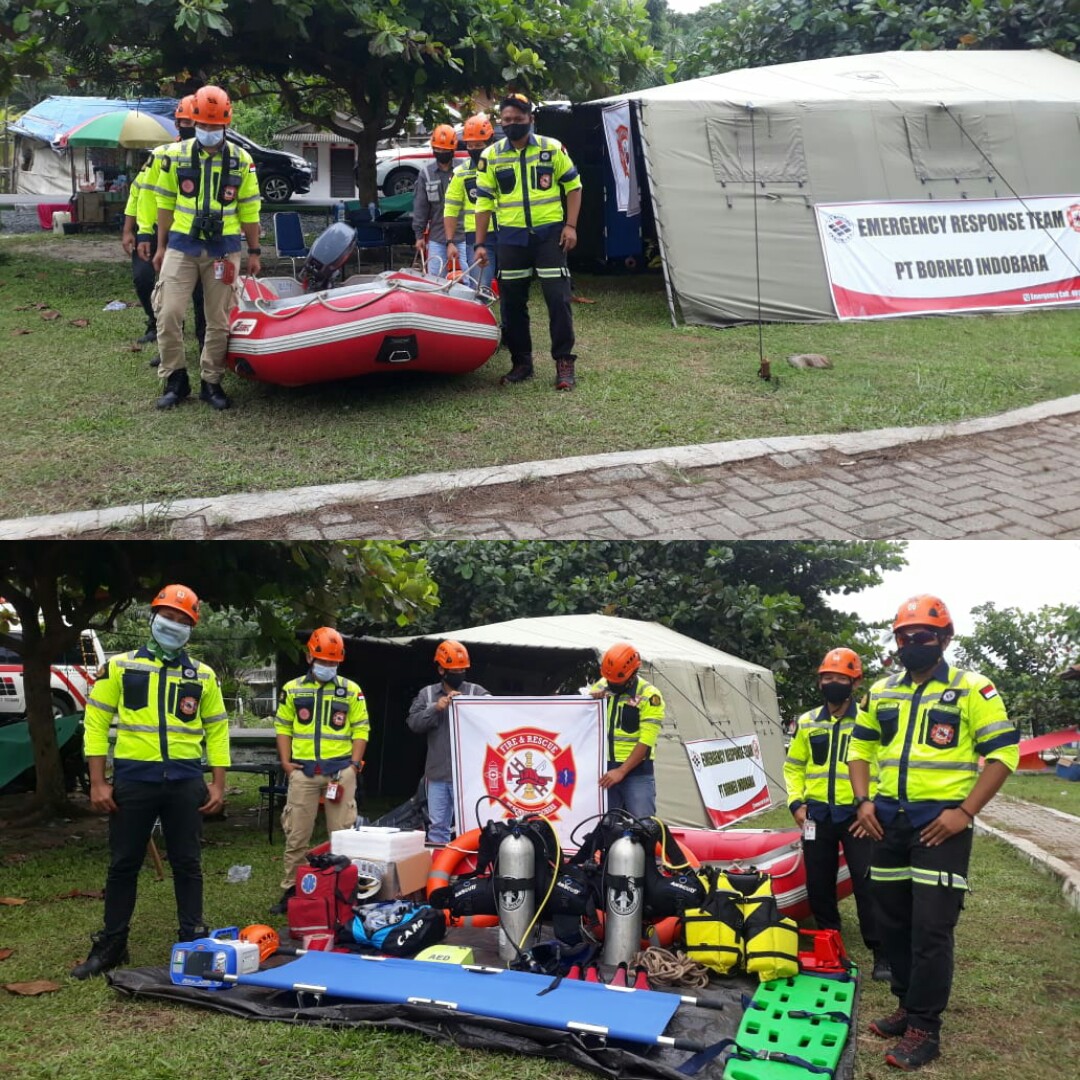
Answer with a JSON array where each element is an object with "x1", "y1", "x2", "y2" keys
[{"x1": 476, "y1": 134, "x2": 581, "y2": 244}]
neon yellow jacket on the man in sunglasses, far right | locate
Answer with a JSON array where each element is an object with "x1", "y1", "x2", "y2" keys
[{"x1": 848, "y1": 660, "x2": 1020, "y2": 804}]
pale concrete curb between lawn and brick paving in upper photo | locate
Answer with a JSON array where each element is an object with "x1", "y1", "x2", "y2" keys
[{"x1": 0, "y1": 394, "x2": 1080, "y2": 540}]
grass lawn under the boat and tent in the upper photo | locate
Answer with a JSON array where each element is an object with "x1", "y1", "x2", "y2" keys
[{"x1": 6, "y1": 235, "x2": 1080, "y2": 515}]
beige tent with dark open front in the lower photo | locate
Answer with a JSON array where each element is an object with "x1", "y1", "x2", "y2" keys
[{"x1": 287, "y1": 615, "x2": 784, "y2": 827}]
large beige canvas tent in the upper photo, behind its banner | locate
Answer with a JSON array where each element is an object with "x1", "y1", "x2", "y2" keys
[{"x1": 587, "y1": 51, "x2": 1080, "y2": 325}]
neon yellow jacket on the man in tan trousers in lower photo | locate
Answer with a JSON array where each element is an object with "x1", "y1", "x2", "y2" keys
[{"x1": 273, "y1": 675, "x2": 370, "y2": 768}]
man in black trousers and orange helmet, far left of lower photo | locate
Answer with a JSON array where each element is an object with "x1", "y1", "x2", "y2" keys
[{"x1": 71, "y1": 585, "x2": 231, "y2": 978}]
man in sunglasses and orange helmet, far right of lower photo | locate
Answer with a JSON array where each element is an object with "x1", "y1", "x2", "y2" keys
[{"x1": 848, "y1": 595, "x2": 1020, "y2": 1070}]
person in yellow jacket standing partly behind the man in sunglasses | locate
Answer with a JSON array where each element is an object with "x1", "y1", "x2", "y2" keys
[{"x1": 784, "y1": 648, "x2": 889, "y2": 982}]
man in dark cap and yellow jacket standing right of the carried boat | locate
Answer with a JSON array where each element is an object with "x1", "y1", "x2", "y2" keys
[{"x1": 473, "y1": 94, "x2": 581, "y2": 390}]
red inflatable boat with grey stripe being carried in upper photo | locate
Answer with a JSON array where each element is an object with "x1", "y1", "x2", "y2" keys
[{"x1": 226, "y1": 270, "x2": 499, "y2": 387}]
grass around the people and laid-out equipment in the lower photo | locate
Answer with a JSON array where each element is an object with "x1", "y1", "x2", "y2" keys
[{"x1": 0, "y1": 777, "x2": 1080, "y2": 1080}]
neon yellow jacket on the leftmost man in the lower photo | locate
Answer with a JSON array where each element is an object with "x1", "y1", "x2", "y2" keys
[{"x1": 83, "y1": 648, "x2": 232, "y2": 780}]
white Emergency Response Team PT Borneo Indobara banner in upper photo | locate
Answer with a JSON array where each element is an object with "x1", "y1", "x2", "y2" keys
[{"x1": 815, "y1": 195, "x2": 1080, "y2": 319}]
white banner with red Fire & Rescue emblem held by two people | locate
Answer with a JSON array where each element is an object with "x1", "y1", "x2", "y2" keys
[{"x1": 449, "y1": 697, "x2": 606, "y2": 847}]
